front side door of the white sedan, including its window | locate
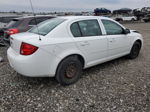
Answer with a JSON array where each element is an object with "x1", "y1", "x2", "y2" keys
[{"x1": 102, "y1": 19, "x2": 130, "y2": 57}]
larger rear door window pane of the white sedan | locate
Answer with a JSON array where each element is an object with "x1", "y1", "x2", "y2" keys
[{"x1": 78, "y1": 20, "x2": 102, "y2": 36}]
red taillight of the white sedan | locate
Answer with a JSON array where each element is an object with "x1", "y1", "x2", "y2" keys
[{"x1": 20, "y1": 42, "x2": 38, "y2": 55}]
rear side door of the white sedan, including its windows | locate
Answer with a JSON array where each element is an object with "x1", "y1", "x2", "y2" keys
[{"x1": 71, "y1": 19, "x2": 107, "y2": 66}]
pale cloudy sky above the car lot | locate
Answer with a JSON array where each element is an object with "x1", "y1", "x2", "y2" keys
[{"x1": 0, "y1": 0, "x2": 150, "y2": 12}]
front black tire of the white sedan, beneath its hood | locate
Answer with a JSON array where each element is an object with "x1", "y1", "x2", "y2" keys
[{"x1": 127, "y1": 41, "x2": 141, "y2": 59}]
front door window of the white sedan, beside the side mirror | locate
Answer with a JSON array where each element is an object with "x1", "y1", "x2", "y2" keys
[{"x1": 102, "y1": 20, "x2": 123, "y2": 35}]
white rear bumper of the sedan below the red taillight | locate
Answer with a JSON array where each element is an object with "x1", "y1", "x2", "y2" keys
[{"x1": 7, "y1": 48, "x2": 55, "y2": 77}]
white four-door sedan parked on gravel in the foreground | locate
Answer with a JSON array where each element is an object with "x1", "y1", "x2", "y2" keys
[{"x1": 7, "y1": 16, "x2": 143, "y2": 85}]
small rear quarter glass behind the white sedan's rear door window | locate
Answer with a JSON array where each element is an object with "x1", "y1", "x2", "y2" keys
[{"x1": 70, "y1": 23, "x2": 82, "y2": 37}]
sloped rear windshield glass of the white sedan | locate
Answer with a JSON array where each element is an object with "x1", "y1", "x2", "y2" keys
[{"x1": 29, "y1": 18, "x2": 65, "y2": 36}]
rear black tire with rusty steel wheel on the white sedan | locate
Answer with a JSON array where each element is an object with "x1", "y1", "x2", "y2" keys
[{"x1": 56, "y1": 56, "x2": 83, "y2": 86}]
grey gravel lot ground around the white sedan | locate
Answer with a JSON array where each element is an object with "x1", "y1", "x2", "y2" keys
[{"x1": 0, "y1": 23, "x2": 150, "y2": 112}]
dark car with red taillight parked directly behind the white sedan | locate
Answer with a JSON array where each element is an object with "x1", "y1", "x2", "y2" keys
[{"x1": 1, "y1": 16, "x2": 54, "y2": 44}]
